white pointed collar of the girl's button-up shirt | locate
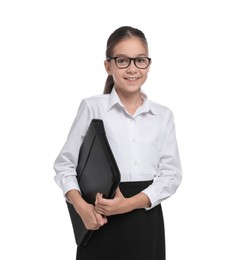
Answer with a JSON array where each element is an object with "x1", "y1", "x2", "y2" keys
[{"x1": 108, "y1": 87, "x2": 156, "y2": 115}]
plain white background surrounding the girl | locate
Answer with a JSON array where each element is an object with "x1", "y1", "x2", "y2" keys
[{"x1": 0, "y1": 0, "x2": 247, "y2": 260}]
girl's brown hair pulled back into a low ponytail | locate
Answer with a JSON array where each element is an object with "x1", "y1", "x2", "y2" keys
[{"x1": 103, "y1": 26, "x2": 148, "y2": 94}]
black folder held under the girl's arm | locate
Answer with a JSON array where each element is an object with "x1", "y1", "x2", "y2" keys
[{"x1": 66, "y1": 119, "x2": 121, "y2": 245}]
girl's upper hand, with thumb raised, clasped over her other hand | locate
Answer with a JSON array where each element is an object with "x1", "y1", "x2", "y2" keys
[{"x1": 95, "y1": 188, "x2": 129, "y2": 216}]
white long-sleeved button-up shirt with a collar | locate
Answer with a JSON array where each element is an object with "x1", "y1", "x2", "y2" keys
[{"x1": 54, "y1": 88, "x2": 182, "y2": 209}]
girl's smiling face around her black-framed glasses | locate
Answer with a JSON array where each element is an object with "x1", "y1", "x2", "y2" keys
[{"x1": 105, "y1": 37, "x2": 150, "y2": 95}]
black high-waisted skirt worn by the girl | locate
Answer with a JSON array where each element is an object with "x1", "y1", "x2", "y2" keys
[{"x1": 76, "y1": 181, "x2": 165, "y2": 260}]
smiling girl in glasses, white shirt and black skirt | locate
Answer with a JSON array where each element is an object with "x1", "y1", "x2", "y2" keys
[{"x1": 54, "y1": 26, "x2": 182, "y2": 260}]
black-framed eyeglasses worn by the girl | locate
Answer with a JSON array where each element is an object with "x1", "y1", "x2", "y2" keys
[{"x1": 107, "y1": 57, "x2": 151, "y2": 69}]
